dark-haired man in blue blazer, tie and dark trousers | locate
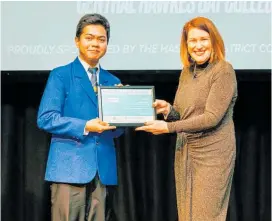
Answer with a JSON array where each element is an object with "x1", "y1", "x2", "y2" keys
[{"x1": 37, "y1": 14, "x2": 122, "y2": 221}]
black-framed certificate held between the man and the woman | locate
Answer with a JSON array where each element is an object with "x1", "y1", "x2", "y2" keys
[{"x1": 98, "y1": 86, "x2": 157, "y2": 127}]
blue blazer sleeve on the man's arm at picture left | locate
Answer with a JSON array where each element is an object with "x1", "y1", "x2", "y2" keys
[{"x1": 37, "y1": 69, "x2": 87, "y2": 140}]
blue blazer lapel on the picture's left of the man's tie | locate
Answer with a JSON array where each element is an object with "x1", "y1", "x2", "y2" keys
[{"x1": 74, "y1": 58, "x2": 97, "y2": 107}]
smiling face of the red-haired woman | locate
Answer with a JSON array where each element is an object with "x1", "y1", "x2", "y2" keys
[{"x1": 187, "y1": 28, "x2": 212, "y2": 64}]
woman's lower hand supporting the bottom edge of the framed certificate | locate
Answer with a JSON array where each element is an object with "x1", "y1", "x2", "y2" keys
[{"x1": 135, "y1": 120, "x2": 169, "y2": 135}]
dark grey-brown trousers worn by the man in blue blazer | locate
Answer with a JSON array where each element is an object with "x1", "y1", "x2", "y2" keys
[{"x1": 51, "y1": 176, "x2": 106, "y2": 221}]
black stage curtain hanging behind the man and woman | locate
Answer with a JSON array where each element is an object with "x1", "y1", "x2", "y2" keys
[{"x1": 1, "y1": 70, "x2": 271, "y2": 221}]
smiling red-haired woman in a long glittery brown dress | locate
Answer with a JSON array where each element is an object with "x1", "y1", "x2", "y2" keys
[{"x1": 136, "y1": 17, "x2": 237, "y2": 221}]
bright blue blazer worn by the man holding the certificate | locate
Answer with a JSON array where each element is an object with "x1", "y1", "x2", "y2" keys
[{"x1": 37, "y1": 58, "x2": 123, "y2": 185}]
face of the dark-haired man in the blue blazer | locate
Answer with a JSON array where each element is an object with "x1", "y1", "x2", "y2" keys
[{"x1": 75, "y1": 25, "x2": 107, "y2": 66}]
